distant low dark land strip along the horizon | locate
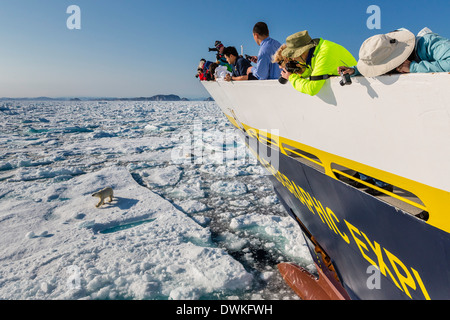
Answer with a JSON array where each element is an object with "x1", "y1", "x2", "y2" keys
[{"x1": 0, "y1": 94, "x2": 214, "y2": 101}]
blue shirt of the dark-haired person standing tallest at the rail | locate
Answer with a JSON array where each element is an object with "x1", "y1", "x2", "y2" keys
[{"x1": 252, "y1": 37, "x2": 281, "y2": 80}]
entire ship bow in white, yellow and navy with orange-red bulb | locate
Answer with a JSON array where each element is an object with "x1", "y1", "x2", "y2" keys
[{"x1": 202, "y1": 73, "x2": 450, "y2": 299}]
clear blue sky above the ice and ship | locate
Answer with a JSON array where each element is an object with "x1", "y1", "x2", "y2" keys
[{"x1": 0, "y1": 0, "x2": 450, "y2": 98}]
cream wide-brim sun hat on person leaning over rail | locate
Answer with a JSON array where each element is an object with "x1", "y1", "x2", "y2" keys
[{"x1": 357, "y1": 30, "x2": 416, "y2": 77}]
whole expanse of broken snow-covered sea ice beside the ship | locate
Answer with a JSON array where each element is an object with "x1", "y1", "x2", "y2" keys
[{"x1": 0, "y1": 101, "x2": 312, "y2": 300}]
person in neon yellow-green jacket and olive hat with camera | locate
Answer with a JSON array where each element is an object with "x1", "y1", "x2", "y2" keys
[{"x1": 280, "y1": 30, "x2": 356, "y2": 96}]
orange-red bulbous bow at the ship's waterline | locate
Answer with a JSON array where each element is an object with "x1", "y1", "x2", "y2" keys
[{"x1": 278, "y1": 262, "x2": 349, "y2": 300}]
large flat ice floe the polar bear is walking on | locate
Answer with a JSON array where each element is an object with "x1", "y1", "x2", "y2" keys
[{"x1": 0, "y1": 167, "x2": 253, "y2": 299}]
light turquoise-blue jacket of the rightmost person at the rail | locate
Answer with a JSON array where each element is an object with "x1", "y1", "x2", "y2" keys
[{"x1": 409, "y1": 33, "x2": 450, "y2": 72}]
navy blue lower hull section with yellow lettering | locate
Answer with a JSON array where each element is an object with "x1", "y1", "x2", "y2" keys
[{"x1": 245, "y1": 135, "x2": 450, "y2": 300}]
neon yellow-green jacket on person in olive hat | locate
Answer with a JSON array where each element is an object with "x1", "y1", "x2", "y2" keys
[{"x1": 289, "y1": 38, "x2": 357, "y2": 96}]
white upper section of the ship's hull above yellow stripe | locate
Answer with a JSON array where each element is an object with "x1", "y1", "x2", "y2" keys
[{"x1": 202, "y1": 73, "x2": 450, "y2": 195}]
